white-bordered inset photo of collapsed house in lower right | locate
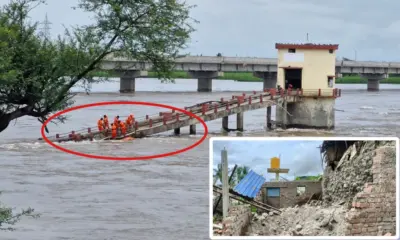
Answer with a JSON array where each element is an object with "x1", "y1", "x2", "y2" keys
[{"x1": 209, "y1": 137, "x2": 399, "y2": 239}]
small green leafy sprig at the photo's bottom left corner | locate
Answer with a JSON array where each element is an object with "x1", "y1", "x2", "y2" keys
[{"x1": 0, "y1": 193, "x2": 40, "y2": 231}]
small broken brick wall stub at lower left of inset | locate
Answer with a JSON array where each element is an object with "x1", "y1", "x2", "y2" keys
[{"x1": 222, "y1": 205, "x2": 253, "y2": 236}]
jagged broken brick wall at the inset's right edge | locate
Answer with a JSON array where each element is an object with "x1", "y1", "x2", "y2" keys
[{"x1": 346, "y1": 143, "x2": 396, "y2": 236}]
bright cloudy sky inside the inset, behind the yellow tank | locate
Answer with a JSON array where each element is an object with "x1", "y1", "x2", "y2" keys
[{"x1": 213, "y1": 140, "x2": 322, "y2": 180}]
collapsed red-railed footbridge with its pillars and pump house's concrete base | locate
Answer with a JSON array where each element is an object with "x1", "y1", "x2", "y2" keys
[{"x1": 45, "y1": 89, "x2": 340, "y2": 142}]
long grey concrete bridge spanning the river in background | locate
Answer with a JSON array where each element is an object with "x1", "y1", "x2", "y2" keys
[{"x1": 101, "y1": 56, "x2": 400, "y2": 92}]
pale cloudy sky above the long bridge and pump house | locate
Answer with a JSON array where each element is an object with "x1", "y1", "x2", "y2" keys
[{"x1": 0, "y1": 0, "x2": 400, "y2": 61}]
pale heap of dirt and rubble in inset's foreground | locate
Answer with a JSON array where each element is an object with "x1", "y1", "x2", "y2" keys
[{"x1": 246, "y1": 204, "x2": 346, "y2": 236}]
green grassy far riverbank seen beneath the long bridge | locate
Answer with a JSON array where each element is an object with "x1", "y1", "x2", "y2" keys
[{"x1": 96, "y1": 71, "x2": 400, "y2": 84}]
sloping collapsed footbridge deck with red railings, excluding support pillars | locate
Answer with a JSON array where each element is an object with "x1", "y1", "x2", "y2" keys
[{"x1": 44, "y1": 89, "x2": 340, "y2": 142}]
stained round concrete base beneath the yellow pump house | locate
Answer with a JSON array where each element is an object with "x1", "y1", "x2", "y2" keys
[{"x1": 276, "y1": 97, "x2": 335, "y2": 129}]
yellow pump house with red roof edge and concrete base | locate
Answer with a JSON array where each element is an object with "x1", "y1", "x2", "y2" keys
[{"x1": 275, "y1": 43, "x2": 339, "y2": 129}]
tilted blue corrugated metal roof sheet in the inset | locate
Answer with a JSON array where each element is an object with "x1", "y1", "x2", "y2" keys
[{"x1": 233, "y1": 170, "x2": 265, "y2": 198}]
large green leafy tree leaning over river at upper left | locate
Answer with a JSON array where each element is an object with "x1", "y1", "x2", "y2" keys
[{"x1": 0, "y1": 0, "x2": 196, "y2": 132}]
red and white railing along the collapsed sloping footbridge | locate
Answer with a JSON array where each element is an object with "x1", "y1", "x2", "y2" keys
[{"x1": 48, "y1": 88, "x2": 341, "y2": 140}]
